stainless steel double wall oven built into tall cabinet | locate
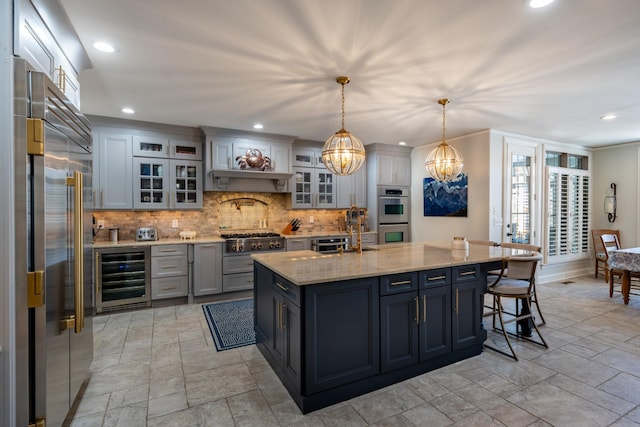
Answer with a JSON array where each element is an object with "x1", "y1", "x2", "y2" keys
[{"x1": 378, "y1": 187, "x2": 409, "y2": 244}]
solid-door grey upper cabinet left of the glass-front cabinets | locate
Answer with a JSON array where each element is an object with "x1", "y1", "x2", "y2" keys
[{"x1": 93, "y1": 130, "x2": 133, "y2": 209}]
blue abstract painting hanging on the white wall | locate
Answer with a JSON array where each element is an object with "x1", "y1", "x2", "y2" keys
[{"x1": 422, "y1": 173, "x2": 467, "y2": 216}]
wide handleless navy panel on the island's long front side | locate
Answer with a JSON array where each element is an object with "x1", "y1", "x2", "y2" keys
[{"x1": 304, "y1": 278, "x2": 380, "y2": 394}]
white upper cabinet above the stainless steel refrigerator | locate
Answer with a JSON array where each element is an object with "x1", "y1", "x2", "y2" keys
[{"x1": 13, "y1": 0, "x2": 91, "y2": 109}]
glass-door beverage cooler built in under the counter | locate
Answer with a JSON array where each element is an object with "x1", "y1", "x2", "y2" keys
[{"x1": 95, "y1": 246, "x2": 151, "y2": 313}]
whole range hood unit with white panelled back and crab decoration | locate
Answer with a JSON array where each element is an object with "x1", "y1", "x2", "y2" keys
[{"x1": 202, "y1": 126, "x2": 294, "y2": 192}]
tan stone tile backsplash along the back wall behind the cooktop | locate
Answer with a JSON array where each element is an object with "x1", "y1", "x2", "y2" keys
[{"x1": 93, "y1": 192, "x2": 356, "y2": 241}]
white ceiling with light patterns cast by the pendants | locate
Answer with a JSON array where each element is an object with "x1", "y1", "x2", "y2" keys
[{"x1": 61, "y1": 0, "x2": 640, "y2": 147}]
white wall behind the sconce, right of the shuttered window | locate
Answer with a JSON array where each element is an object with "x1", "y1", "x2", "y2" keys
[{"x1": 592, "y1": 143, "x2": 640, "y2": 248}]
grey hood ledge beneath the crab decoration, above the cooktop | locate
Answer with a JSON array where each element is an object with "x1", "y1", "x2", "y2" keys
[{"x1": 205, "y1": 169, "x2": 293, "y2": 193}]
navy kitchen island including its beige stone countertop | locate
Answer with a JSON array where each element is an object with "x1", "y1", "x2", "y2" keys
[{"x1": 253, "y1": 242, "x2": 511, "y2": 413}]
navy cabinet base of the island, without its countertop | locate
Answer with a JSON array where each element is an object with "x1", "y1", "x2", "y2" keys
[{"x1": 253, "y1": 262, "x2": 486, "y2": 413}]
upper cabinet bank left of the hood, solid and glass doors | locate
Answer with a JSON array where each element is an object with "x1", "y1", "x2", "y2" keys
[{"x1": 90, "y1": 117, "x2": 204, "y2": 210}]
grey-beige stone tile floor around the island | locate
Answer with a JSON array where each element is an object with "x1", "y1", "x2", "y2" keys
[{"x1": 71, "y1": 277, "x2": 640, "y2": 427}]
